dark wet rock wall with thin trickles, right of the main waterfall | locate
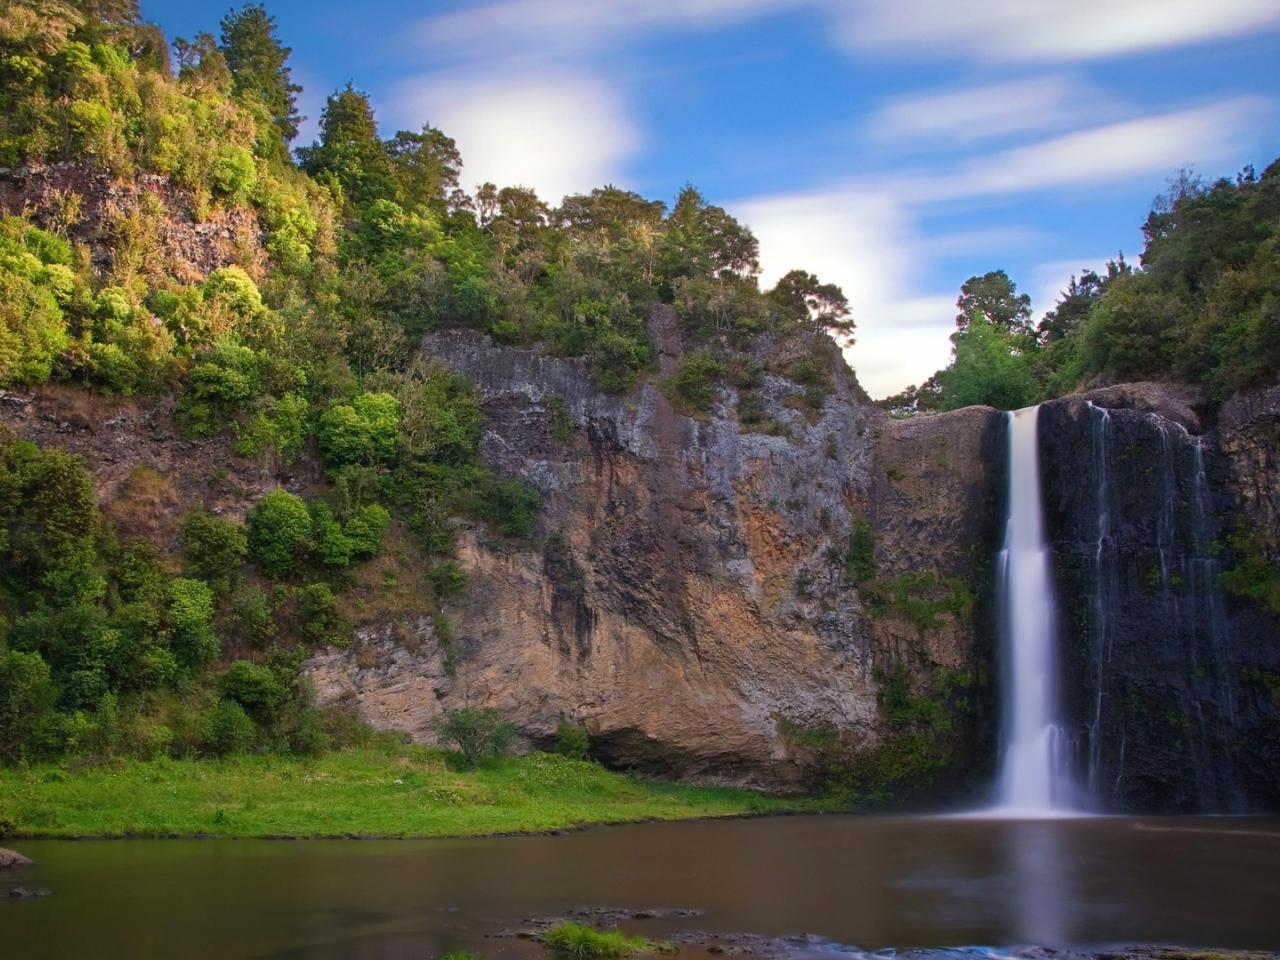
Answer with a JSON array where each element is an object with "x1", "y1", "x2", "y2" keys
[{"x1": 1041, "y1": 384, "x2": 1280, "y2": 813}]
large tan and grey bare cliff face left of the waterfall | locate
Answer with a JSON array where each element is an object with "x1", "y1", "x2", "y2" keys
[{"x1": 311, "y1": 316, "x2": 1001, "y2": 787}]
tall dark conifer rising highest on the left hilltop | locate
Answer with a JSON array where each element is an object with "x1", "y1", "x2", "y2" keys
[{"x1": 219, "y1": 4, "x2": 302, "y2": 146}]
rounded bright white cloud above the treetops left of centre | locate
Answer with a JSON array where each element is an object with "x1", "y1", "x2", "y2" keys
[{"x1": 393, "y1": 72, "x2": 641, "y2": 204}]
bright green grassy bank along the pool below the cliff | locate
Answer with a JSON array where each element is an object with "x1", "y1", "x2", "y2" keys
[{"x1": 0, "y1": 748, "x2": 839, "y2": 837}]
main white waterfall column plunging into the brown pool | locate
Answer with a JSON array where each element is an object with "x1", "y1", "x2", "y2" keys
[{"x1": 996, "y1": 407, "x2": 1075, "y2": 817}]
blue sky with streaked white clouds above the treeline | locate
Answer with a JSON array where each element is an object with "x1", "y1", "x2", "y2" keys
[{"x1": 143, "y1": 0, "x2": 1280, "y2": 396}]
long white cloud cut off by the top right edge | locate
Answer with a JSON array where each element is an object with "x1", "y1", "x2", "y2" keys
[{"x1": 836, "y1": 0, "x2": 1280, "y2": 63}]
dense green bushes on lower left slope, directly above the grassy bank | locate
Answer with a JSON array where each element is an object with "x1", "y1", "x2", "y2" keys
[{"x1": 0, "y1": 434, "x2": 360, "y2": 762}]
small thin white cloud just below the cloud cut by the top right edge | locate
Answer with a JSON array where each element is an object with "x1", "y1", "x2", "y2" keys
[{"x1": 865, "y1": 76, "x2": 1108, "y2": 146}]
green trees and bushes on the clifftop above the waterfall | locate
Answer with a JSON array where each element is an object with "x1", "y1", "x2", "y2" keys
[{"x1": 883, "y1": 161, "x2": 1280, "y2": 412}]
